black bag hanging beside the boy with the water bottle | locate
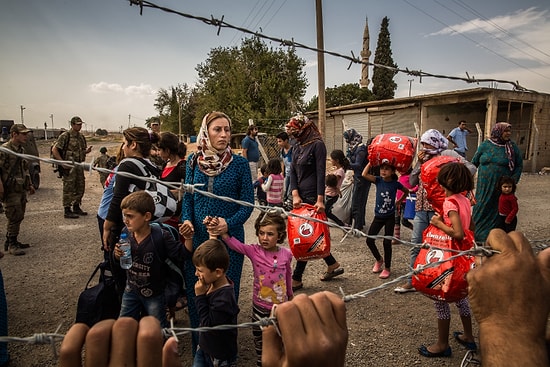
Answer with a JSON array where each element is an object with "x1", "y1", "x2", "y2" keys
[{"x1": 75, "y1": 261, "x2": 121, "y2": 327}]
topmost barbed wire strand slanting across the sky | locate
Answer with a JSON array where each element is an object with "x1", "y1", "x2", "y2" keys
[{"x1": 125, "y1": 0, "x2": 539, "y2": 94}]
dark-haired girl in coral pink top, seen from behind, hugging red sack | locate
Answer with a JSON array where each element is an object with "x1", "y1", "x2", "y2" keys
[{"x1": 418, "y1": 163, "x2": 477, "y2": 357}]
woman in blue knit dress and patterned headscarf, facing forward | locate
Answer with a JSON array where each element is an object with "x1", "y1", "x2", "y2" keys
[{"x1": 181, "y1": 112, "x2": 254, "y2": 354}]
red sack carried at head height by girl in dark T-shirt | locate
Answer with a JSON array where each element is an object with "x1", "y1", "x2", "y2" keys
[{"x1": 368, "y1": 134, "x2": 416, "y2": 173}]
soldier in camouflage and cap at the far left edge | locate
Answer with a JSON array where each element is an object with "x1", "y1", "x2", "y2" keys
[{"x1": 0, "y1": 124, "x2": 34, "y2": 256}]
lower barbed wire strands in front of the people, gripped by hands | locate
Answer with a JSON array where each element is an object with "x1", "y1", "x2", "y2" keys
[{"x1": 0, "y1": 146, "x2": 550, "y2": 366}]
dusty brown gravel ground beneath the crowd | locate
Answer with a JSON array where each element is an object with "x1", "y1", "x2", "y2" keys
[{"x1": 0, "y1": 137, "x2": 550, "y2": 367}]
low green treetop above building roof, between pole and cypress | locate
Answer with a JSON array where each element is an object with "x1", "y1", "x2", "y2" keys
[{"x1": 306, "y1": 83, "x2": 374, "y2": 111}]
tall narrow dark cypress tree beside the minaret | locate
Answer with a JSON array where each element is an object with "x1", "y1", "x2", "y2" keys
[{"x1": 372, "y1": 17, "x2": 397, "y2": 100}]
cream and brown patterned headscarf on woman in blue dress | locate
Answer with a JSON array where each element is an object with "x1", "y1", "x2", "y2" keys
[{"x1": 197, "y1": 111, "x2": 233, "y2": 177}]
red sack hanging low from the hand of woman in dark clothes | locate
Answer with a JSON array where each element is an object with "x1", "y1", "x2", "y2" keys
[{"x1": 287, "y1": 204, "x2": 330, "y2": 261}]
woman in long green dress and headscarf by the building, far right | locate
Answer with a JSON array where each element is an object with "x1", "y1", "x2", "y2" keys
[{"x1": 472, "y1": 122, "x2": 523, "y2": 242}]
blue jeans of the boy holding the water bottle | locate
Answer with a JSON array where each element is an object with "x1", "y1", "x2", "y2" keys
[{"x1": 120, "y1": 287, "x2": 169, "y2": 328}]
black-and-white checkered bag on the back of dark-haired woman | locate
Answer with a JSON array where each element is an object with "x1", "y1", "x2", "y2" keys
[{"x1": 125, "y1": 158, "x2": 178, "y2": 222}]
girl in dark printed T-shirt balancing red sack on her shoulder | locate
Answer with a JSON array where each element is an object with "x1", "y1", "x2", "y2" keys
[{"x1": 363, "y1": 162, "x2": 409, "y2": 279}]
